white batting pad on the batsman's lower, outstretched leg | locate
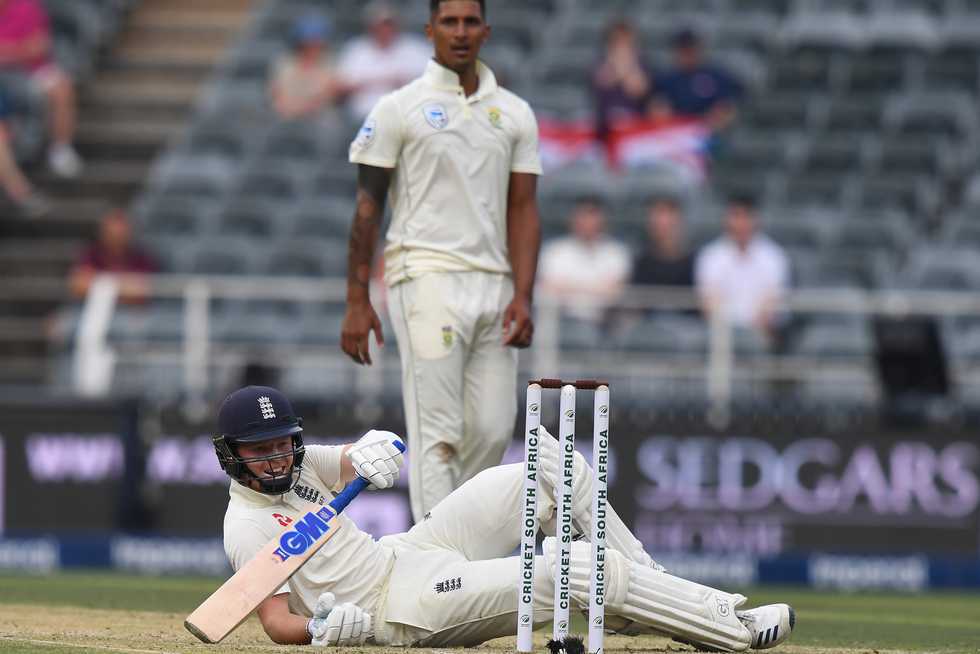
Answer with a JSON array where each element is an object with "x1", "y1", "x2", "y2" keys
[{"x1": 543, "y1": 538, "x2": 751, "y2": 652}]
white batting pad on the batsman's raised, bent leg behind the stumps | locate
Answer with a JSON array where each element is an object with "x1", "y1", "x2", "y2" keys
[{"x1": 538, "y1": 426, "x2": 656, "y2": 568}]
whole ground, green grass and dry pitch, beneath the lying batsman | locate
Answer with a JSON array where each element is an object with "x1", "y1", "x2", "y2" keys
[{"x1": 0, "y1": 575, "x2": 980, "y2": 654}]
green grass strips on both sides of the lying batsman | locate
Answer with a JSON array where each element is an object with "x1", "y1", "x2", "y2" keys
[{"x1": 0, "y1": 574, "x2": 980, "y2": 654}]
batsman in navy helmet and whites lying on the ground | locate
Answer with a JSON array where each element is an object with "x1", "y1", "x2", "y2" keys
[{"x1": 214, "y1": 386, "x2": 795, "y2": 651}]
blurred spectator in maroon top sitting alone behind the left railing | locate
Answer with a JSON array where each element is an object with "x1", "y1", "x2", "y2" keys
[{"x1": 69, "y1": 208, "x2": 159, "y2": 304}]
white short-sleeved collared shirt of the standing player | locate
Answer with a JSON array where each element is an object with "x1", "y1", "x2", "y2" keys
[{"x1": 350, "y1": 60, "x2": 541, "y2": 286}]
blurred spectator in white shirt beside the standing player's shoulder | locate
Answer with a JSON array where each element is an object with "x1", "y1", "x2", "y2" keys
[{"x1": 338, "y1": 0, "x2": 432, "y2": 121}]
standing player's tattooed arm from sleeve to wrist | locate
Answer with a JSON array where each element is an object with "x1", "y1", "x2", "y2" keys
[{"x1": 347, "y1": 165, "x2": 391, "y2": 288}]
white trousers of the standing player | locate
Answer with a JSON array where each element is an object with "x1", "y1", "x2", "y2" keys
[{"x1": 388, "y1": 272, "x2": 517, "y2": 522}]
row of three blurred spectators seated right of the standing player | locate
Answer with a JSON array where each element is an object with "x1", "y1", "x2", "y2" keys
[{"x1": 538, "y1": 196, "x2": 790, "y2": 348}]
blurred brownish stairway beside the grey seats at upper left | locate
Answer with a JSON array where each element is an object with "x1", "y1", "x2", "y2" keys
[{"x1": 0, "y1": 0, "x2": 258, "y2": 385}]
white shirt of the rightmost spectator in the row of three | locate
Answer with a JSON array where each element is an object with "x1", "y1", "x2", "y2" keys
[{"x1": 694, "y1": 234, "x2": 789, "y2": 327}]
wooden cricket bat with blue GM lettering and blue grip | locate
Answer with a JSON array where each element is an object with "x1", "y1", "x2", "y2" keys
[{"x1": 184, "y1": 443, "x2": 405, "y2": 644}]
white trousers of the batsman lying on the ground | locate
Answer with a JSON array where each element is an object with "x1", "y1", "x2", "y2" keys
[{"x1": 375, "y1": 464, "x2": 554, "y2": 647}]
